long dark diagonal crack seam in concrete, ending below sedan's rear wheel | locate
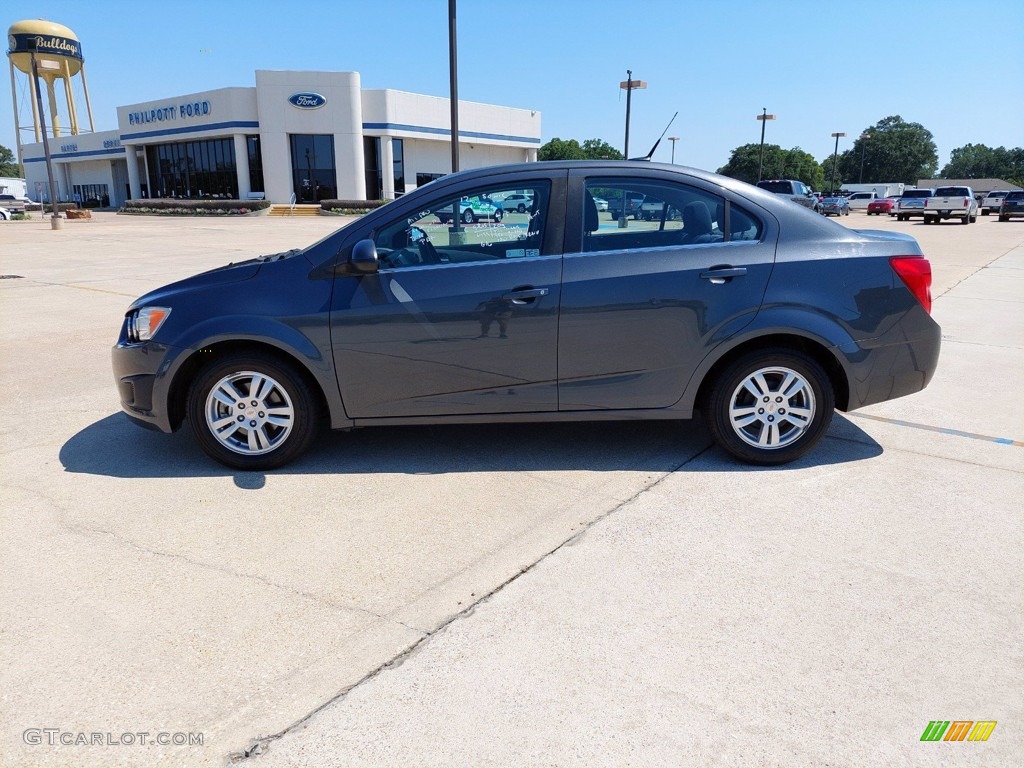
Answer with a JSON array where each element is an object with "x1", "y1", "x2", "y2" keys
[{"x1": 227, "y1": 443, "x2": 713, "y2": 763}]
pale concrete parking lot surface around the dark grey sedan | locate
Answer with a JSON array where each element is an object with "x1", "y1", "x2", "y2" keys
[{"x1": 0, "y1": 207, "x2": 1024, "y2": 767}]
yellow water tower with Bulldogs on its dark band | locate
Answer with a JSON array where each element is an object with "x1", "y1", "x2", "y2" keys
[{"x1": 7, "y1": 18, "x2": 95, "y2": 163}]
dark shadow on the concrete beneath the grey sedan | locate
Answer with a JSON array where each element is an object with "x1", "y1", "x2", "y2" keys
[{"x1": 59, "y1": 413, "x2": 882, "y2": 489}]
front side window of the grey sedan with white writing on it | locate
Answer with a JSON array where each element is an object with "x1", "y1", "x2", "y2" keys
[{"x1": 374, "y1": 181, "x2": 550, "y2": 269}]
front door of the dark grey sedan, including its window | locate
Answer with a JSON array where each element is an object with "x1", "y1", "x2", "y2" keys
[{"x1": 331, "y1": 180, "x2": 561, "y2": 419}]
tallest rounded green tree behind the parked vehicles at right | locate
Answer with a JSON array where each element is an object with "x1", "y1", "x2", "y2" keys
[{"x1": 839, "y1": 115, "x2": 939, "y2": 184}]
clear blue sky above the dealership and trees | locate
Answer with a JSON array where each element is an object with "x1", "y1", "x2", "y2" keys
[{"x1": 0, "y1": 0, "x2": 1024, "y2": 170}]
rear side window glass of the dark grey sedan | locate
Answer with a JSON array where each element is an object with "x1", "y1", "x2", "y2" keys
[{"x1": 583, "y1": 177, "x2": 761, "y2": 252}]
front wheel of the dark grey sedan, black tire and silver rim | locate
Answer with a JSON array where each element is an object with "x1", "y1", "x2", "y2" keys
[{"x1": 187, "y1": 352, "x2": 319, "y2": 471}]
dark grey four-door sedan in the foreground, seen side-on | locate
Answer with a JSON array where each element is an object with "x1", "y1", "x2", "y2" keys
[{"x1": 113, "y1": 161, "x2": 940, "y2": 470}]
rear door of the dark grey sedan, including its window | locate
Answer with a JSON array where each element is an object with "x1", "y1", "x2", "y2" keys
[{"x1": 558, "y1": 169, "x2": 778, "y2": 411}]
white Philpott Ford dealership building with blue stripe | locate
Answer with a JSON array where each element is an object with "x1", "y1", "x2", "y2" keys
[{"x1": 24, "y1": 70, "x2": 541, "y2": 206}]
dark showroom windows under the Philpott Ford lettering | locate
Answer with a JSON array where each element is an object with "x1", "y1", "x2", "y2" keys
[{"x1": 145, "y1": 138, "x2": 239, "y2": 200}]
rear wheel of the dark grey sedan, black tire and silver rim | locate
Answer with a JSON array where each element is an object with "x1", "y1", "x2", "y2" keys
[{"x1": 703, "y1": 349, "x2": 836, "y2": 466}]
